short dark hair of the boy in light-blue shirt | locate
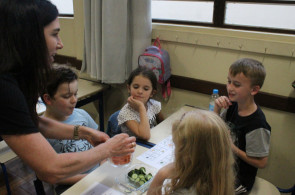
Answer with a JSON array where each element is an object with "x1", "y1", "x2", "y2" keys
[{"x1": 41, "y1": 65, "x2": 78, "y2": 102}]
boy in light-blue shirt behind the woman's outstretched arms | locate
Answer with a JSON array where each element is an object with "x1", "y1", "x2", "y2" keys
[{"x1": 41, "y1": 65, "x2": 99, "y2": 189}]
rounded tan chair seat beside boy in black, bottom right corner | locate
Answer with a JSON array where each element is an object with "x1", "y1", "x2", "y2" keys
[{"x1": 249, "y1": 177, "x2": 280, "y2": 195}]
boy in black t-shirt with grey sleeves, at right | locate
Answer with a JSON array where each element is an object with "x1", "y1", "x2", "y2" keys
[{"x1": 214, "y1": 58, "x2": 271, "y2": 194}]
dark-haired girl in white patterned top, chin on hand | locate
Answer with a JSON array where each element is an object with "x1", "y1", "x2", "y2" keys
[{"x1": 118, "y1": 67, "x2": 164, "y2": 140}]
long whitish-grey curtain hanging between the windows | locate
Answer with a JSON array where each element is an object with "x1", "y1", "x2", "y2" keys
[{"x1": 81, "y1": 0, "x2": 152, "y2": 83}]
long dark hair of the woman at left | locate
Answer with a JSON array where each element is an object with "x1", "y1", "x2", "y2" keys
[{"x1": 0, "y1": 0, "x2": 58, "y2": 124}]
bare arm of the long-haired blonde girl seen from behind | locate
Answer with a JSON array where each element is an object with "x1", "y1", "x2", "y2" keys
[{"x1": 147, "y1": 163, "x2": 175, "y2": 195}]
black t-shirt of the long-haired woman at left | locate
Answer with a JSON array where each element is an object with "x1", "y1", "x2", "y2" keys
[{"x1": 0, "y1": 74, "x2": 38, "y2": 136}]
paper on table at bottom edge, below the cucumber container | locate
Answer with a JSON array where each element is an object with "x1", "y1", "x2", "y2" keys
[{"x1": 81, "y1": 182, "x2": 123, "y2": 195}]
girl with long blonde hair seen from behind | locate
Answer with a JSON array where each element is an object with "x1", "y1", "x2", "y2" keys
[{"x1": 148, "y1": 110, "x2": 234, "y2": 195}]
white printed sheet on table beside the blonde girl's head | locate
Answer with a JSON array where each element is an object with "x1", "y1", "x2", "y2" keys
[{"x1": 137, "y1": 135, "x2": 174, "y2": 169}]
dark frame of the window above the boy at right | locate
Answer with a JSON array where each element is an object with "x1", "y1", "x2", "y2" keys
[{"x1": 152, "y1": 0, "x2": 295, "y2": 34}]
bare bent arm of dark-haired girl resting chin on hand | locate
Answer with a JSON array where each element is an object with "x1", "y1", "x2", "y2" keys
[{"x1": 125, "y1": 96, "x2": 151, "y2": 140}]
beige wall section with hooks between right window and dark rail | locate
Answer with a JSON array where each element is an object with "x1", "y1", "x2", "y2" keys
[{"x1": 153, "y1": 24, "x2": 295, "y2": 97}]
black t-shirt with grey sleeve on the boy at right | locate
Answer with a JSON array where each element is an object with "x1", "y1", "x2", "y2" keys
[{"x1": 225, "y1": 102, "x2": 271, "y2": 191}]
